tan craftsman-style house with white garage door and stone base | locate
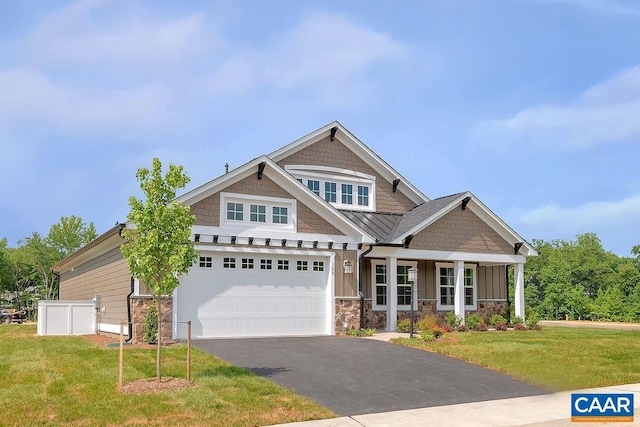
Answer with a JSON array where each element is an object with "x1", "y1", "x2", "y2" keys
[{"x1": 55, "y1": 122, "x2": 536, "y2": 338}]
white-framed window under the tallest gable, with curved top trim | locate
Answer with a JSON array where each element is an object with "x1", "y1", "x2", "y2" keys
[{"x1": 285, "y1": 165, "x2": 376, "y2": 211}]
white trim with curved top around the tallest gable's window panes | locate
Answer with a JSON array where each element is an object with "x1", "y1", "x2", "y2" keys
[{"x1": 285, "y1": 165, "x2": 376, "y2": 212}]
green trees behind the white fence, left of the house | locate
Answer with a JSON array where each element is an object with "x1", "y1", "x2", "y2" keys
[{"x1": 0, "y1": 215, "x2": 98, "y2": 311}]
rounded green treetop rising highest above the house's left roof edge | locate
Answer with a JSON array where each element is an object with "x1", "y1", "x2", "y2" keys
[{"x1": 47, "y1": 215, "x2": 98, "y2": 258}]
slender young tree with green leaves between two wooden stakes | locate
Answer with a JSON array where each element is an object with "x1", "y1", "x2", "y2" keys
[{"x1": 121, "y1": 158, "x2": 196, "y2": 381}]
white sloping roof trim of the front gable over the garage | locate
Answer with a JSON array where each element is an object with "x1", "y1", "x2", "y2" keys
[{"x1": 175, "y1": 155, "x2": 375, "y2": 243}]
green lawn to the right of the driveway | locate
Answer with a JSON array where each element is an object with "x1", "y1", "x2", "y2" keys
[{"x1": 393, "y1": 328, "x2": 640, "y2": 391}]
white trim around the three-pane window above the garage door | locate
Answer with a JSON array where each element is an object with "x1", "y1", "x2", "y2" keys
[{"x1": 220, "y1": 192, "x2": 298, "y2": 232}]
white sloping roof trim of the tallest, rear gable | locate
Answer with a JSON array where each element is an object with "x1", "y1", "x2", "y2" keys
[{"x1": 268, "y1": 121, "x2": 429, "y2": 205}]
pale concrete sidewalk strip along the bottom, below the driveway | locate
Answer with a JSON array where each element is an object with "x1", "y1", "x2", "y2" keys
[{"x1": 270, "y1": 384, "x2": 640, "y2": 427}]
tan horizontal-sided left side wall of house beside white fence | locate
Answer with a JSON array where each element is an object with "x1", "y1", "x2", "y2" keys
[{"x1": 60, "y1": 248, "x2": 131, "y2": 325}]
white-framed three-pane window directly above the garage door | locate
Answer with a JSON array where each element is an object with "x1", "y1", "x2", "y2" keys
[{"x1": 220, "y1": 193, "x2": 296, "y2": 231}]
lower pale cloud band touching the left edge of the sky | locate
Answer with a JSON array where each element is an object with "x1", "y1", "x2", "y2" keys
[{"x1": 0, "y1": 68, "x2": 169, "y2": 129}]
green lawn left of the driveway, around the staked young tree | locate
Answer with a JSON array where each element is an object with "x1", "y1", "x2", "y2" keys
[{"x1": 0, "y1": 325, "x2": 335, "y2": 426}]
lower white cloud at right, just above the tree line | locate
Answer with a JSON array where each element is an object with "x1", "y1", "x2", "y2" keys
[{"x1": 510, "y1": 195, "x2": 640, "y2": 232}]
